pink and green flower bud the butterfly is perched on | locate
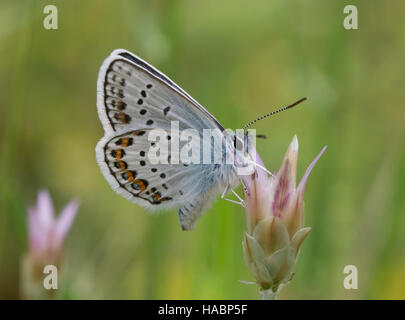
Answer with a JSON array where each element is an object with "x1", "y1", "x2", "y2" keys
[{"x1": 242, "y1": 136, "x2": 326, "y2": 298}]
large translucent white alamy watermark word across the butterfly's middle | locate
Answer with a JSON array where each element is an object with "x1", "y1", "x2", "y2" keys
[{"x1": 140, "y1": 121, "x2": 257, "y2": 175}]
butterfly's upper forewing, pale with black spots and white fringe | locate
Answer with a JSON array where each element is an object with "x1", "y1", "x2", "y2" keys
[{"x1": 97, "y1": 49, "x2": 224, "y2": 134}]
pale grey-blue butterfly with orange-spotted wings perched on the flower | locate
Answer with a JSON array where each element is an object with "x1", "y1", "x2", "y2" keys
[{"x1": 96, "y1": 49, "x2": 258, "y2": 230}]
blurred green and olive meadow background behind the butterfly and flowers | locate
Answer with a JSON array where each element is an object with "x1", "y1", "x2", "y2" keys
[{"x1": 0, "y1": 0, "x2": 405, "y2": 299}]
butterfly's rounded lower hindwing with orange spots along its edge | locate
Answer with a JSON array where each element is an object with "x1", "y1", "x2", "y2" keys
[{"x1": 96, "y1": 128, "x2": 227, "y2": 215}]
